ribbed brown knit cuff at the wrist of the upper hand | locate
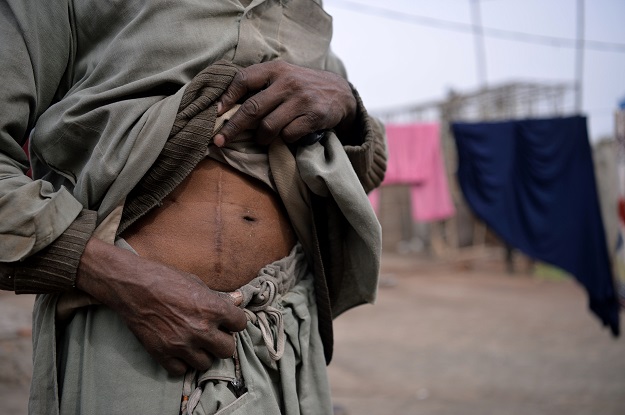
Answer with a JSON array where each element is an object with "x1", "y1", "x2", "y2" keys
[{"x1": 344, "y1": 86, "x2": 387, "y2": 193}]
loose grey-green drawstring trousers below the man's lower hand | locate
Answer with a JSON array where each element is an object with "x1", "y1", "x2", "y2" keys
[{"x1": 50, "y1": 246, "x2": 331, "y2": 415}]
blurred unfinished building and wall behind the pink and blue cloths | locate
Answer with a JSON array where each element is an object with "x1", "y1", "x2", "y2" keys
[{"x1": 368, "y1": 82, "x2": 575, "y2": 259}]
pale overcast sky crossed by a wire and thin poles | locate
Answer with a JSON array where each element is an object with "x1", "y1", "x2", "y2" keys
[{"x1": 324, "y1": 0, "x2": 625, "y2": 139}]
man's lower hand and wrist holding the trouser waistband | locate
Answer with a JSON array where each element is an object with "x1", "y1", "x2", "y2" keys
[{"x1": 77, "y1": 239, "x2": 247, "y2": 375}]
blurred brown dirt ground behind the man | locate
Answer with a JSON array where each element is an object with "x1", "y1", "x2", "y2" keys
[{"x1": 0, "y1": 255, "x2": 625, "y2": 415}]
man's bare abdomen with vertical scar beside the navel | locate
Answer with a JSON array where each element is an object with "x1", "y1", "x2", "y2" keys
[{"x1": 122, "y1": 159, "x2": 295, "y2": 291}]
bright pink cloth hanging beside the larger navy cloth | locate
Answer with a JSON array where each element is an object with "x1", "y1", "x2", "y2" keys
[{"x1": 369, "y1": 123, "x2": 455, "y2": 222}]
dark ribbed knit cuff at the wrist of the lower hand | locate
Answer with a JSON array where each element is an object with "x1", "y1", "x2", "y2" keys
[{"x1": 10, "y1": 209, "x2": 97, "y2": 294}]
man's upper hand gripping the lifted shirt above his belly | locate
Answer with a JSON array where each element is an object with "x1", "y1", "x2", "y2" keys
[{"x1": 213, "y1": 61, "x2": 357, "y2": 147}]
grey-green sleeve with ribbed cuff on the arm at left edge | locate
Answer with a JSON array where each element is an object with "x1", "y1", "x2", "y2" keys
[{"x1": 0, "y1": 0, "x2": 95, "y2": 292}]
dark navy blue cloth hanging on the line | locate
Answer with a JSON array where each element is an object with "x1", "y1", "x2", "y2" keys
[{"x1": 452, "y1": 116, "x2": 619, "y2": 335}]
